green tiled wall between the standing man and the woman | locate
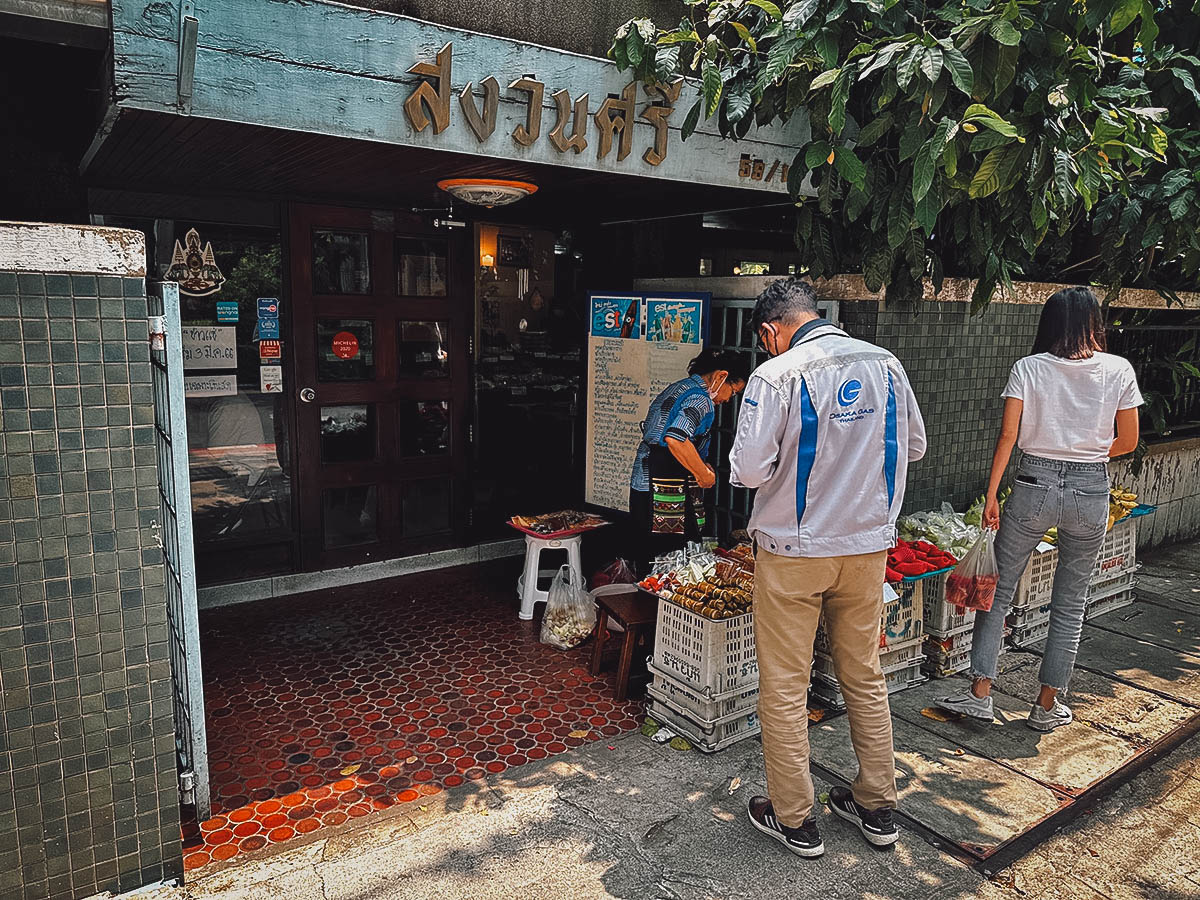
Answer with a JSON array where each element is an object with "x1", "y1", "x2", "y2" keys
[{"x1": 840, "y1": 301, "x2": 1042, "y2": 511}]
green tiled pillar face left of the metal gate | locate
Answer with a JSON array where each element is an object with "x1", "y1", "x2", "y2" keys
[{"x1": 0, "y1": 271, "x2": 182, "y2": 900}]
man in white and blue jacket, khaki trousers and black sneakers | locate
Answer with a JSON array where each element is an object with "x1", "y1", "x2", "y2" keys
[{"x1": 730, "y1": 278, "x2": 925, "y2": 857}]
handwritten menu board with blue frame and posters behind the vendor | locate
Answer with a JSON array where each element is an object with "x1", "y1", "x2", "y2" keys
[{"x1": 583, "y1": 293, "x2": 709, "y2": 511}]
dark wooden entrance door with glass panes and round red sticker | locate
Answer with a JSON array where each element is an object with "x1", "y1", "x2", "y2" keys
[{"x1": 289, "y1": 205, "x2": 473, "y2": 571}]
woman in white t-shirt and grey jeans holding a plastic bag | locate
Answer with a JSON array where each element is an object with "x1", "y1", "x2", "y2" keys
[{"x1": 937, "y1": 288, "x2": 1142, "y2": 732}]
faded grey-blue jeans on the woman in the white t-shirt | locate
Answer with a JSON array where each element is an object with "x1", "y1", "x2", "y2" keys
[{"x1": 971, "y1": 456, "x2": 1109, "y2": 691}]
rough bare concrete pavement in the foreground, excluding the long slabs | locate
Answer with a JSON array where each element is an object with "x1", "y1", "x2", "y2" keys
[{"x1": 117, "y1": 734, "x2": 1200, "y2": 900}]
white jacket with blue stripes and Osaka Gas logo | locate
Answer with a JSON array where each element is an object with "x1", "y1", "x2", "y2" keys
[{"x1": 730, "y1": 324, "x2": 925, "y2": 557}]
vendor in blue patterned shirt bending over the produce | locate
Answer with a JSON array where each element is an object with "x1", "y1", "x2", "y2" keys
[{"x1": 629, "y1": 349, "x2": 750, "y2": 574}]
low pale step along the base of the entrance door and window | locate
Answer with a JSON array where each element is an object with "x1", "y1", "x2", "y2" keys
[{"x1": 197, "y1": 538, "x2": 524, "y2": 610}]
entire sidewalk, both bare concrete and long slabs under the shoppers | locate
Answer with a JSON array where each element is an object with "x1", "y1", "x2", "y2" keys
[{"x1": 105, "y1": 545, "x2": 1200, "y2": 900}]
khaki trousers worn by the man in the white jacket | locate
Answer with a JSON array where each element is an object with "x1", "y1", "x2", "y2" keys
[{"x1": 754, "y1": 547, "x2": 896, "y2": 828}]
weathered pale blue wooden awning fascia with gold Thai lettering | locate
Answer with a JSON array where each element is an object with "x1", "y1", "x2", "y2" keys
[{"x1": 88, "y1": 0, "x2": 808, "y2": 199}]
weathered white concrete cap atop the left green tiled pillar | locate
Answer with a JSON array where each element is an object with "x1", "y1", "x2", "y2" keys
[{"x1": 0, "y1": 221, "x2": 146, "y2": 278}]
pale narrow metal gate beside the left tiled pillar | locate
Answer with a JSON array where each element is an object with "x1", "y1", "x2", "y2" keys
[{"x1": 148, "y1": 282, "x2": 211, "y2": 822}]
